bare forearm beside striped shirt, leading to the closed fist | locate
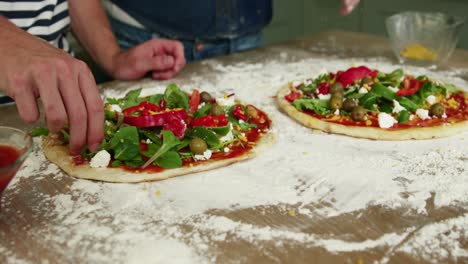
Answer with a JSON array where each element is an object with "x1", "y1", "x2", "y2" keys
[{"x1": 68, "y1": 0, "x2": 120, "y2": 75}]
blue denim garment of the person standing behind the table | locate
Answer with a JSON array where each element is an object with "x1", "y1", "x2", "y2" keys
[{"x1": 109, "y1": 17, "x2": 262, "y2": 62}]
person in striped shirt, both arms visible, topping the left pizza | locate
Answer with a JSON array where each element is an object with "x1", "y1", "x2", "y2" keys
[{"x1": 0, "y1": 0, "x2": 185, "y2": 155}]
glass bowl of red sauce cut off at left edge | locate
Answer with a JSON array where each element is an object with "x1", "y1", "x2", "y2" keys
[{"x1": 0, "y1": 126, "x2": 33, "y2": 196}]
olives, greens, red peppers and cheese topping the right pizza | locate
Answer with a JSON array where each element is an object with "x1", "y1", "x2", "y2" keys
[{"x1": 285, "y1": 66, "x2": 468, "y2": 129}]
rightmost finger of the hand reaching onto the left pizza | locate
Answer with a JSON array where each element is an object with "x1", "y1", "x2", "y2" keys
[{"x1": 78, "y1": 62, "x2": 104, "y2": 151}]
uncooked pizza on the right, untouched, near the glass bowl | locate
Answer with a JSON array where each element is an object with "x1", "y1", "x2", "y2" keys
[{"x1": 277, "y1": 66, "x2": 468, "y2": 140}]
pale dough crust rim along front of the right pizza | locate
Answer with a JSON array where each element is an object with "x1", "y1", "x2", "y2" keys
[{"x1": 277, "y1": 85, "x2": 468, "y2": 140}]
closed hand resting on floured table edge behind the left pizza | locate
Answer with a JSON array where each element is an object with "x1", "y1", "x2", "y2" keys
[{"x1": 112, "y1": 39, "x2": 185, "y2": 80}]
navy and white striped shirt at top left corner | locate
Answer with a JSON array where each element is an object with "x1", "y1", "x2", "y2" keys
[{"x1": 0, "y1": 0, "x2": 70, "y2": 52}]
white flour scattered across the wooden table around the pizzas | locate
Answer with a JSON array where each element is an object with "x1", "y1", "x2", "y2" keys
[{"x1": 0, "y1": 54, "x2": 468, "y2": 263}]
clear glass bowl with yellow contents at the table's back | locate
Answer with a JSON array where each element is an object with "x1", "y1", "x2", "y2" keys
[{"x1": 385, "y1": 12, "x2": 464, "y2": 66}]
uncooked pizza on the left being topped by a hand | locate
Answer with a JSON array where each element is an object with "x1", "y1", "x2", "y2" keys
[{"x1": 43, "y1": 84, "x2": 274, "y2": 182}]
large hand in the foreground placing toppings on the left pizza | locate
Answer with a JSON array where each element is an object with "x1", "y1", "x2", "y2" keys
[{"x1": 0, "y1": 17, "x2": 104, "y2": 155}]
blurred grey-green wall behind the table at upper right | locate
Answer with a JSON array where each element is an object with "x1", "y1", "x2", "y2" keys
[{"x1": 264, "y1": 0, "x2": 468, "y2": 49}]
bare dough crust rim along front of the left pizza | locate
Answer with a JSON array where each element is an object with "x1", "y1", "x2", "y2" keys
[{"x1": 42, "y1": 132, "x2": 275, "y2": 183}]
